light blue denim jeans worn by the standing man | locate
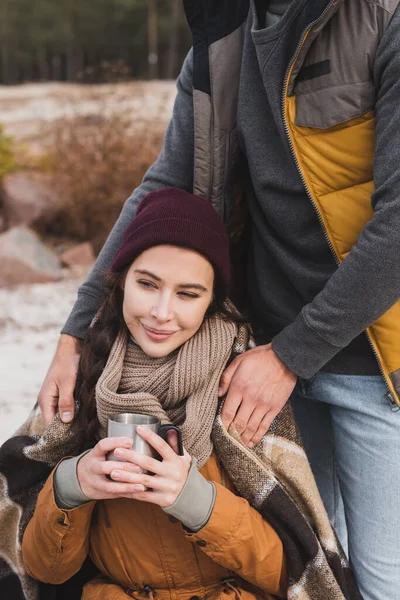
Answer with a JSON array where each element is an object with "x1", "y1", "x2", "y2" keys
[{"x1": 291, "y1": 373, "x2": 400, "y2": 600}]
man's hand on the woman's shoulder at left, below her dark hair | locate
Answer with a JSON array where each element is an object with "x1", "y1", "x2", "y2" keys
[{"x1": 38, "y1": 334, "x2": 81, "y2": 425}]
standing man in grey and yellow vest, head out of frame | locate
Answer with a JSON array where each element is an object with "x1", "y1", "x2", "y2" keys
[{"x1": 39, "y1": 0, "x2": 400, "y2": 600}]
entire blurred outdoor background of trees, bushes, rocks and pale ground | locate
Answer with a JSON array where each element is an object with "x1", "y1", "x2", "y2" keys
[{"x1": 0, "y1": 0, "x2": 191, "y2": 444}]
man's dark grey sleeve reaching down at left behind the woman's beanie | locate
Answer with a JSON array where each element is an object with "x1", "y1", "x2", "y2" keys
[{"x1": 61, "y1": 51, "x2": 194, "y2": 339}]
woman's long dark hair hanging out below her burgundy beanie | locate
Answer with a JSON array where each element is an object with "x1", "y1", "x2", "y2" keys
[{"x1": 75, "y1": 267, "x2": 246, "y2": 442}]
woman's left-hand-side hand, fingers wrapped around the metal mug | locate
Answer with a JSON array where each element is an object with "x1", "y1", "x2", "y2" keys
[{"x1": 77, "y1": 437, "x2": 143, "y2": 500}]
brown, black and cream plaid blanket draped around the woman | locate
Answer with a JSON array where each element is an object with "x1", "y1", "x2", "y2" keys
[{"x1": 0, "y1": 394, "x2": 361, "y2": 600}]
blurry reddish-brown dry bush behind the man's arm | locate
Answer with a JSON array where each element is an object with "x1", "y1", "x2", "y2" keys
[{"x1": 36, "y1": 111, "x2": 165, "y2": 252}]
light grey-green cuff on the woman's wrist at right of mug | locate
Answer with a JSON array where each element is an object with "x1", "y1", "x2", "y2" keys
[{"x1": 164, "y1": 458, "x2": 216, "y2": 532}]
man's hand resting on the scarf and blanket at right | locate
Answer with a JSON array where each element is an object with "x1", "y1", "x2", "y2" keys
[{"x1": 218, "y1": 344, "x2": 297, "y2": 447}]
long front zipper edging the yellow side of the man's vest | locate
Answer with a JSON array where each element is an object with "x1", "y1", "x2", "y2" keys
[{"x1": 282, "y1": 0, "x2": 400, "y2": 411}]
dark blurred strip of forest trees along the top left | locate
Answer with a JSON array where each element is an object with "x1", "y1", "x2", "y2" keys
[{"x1": 0, "y1": 0, "x2": 190, "y2": 85}]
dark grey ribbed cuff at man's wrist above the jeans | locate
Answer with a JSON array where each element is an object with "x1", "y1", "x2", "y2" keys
[{"x1": 272, "y1": 313, "x2": 341, "y2": 379}]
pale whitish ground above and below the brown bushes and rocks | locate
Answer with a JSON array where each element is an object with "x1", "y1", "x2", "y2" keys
[{"x1": 0, "y1": 81, "x2": 176, "y2": 444}]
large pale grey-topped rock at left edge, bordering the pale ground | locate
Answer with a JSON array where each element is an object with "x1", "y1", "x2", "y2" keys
[{"x1": 0, "y1": 227, "x2": 62, "y2": 287}]
